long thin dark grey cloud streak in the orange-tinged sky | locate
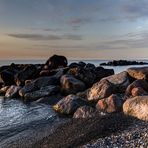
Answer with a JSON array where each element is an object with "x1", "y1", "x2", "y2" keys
[{"x1": 7, "y1": 33, "x2": 82, "y2": 41}]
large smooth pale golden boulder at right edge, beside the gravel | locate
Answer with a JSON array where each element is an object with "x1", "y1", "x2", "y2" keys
[{"x1": 123, "y1": 96, "x2": 148, "y2": 121}]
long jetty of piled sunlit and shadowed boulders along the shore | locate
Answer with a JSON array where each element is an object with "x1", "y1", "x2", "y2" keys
[{"x1": 0, "y1": 55, "x2": 148, "y2": 147}]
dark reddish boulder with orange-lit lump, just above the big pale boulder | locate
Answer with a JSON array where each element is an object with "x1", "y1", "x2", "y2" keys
[{"x1": 125, "y1": 80, "x2": 148, "y2": 96}]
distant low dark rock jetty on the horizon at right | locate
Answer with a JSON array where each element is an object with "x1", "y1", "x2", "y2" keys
[{"x1": 100, "y1": 60, "x2": 148, "y2": 66}]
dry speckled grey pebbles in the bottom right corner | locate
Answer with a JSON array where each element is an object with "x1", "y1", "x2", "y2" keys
[{"x1": 82, "y1": 120, "x2": 148, "y2": 148}]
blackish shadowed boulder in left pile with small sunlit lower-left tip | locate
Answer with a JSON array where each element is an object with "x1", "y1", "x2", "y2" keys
[{"x1": 15, "y1": 65, "x2": 38, "y2": 86}]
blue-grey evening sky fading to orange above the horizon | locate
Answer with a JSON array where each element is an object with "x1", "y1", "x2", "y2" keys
[{"x1": 0, "y1": 0, "x2": 148, "y2": 60}]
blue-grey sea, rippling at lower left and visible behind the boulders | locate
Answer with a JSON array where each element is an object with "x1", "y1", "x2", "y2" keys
[{"x1": 0, "y1": 60, "x2": 148, "y2": 148}]
